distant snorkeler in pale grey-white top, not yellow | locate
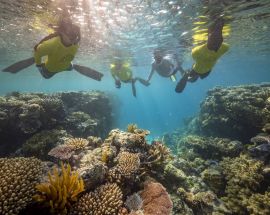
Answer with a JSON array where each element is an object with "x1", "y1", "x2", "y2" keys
[{"x1": 147, "y1": 50, "x2": 182, "y2": 82}]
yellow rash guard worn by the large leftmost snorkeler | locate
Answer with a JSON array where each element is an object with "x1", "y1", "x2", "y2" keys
[{"x1": 34, "y1": 36, "x2": 79, "y2": 73}]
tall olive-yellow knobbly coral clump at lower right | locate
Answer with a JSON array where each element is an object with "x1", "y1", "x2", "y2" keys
[{"x1": 220, "y1": 155, "x2": 263, "y2": 214}]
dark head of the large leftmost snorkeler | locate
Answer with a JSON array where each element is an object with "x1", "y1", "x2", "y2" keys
[{"x1": 57, "y1": 18, "x2": 81, "y2": 45}]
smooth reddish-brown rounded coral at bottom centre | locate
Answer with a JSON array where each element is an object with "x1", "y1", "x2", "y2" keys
[{"x1": 140, "y1": 182, "x2": 173, "y2": 215}]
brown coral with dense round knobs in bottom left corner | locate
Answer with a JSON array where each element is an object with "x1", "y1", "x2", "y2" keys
[{"x1": 0, "y1": 157, "x2": 43, "y2": 215}]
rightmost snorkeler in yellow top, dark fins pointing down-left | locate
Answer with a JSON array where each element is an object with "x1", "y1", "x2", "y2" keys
[{"x1": 175, "y1": 18, "x2": 229, "y2": 93}]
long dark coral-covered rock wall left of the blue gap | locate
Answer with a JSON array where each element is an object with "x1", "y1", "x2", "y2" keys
[{"x1": 0, "y1": 91, "x2": 112, "y2": 156}]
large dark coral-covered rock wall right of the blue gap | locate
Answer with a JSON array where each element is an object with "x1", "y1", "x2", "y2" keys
[{"x1": 191, "y1": 85, "x2": 270, "y2": 142}]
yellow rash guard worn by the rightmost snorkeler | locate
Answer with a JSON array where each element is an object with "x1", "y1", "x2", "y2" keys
[{"x1": 192, "y1": 43, "x2": 229, "y2": 74}]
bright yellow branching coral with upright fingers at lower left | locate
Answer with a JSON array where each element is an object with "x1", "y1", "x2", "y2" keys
[{"x1": 34, "y1": 164, "x2": 84, "y2": 214}]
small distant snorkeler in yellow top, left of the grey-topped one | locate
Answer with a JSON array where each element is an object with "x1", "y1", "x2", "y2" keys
[{"x1": 111, "y1": 60, "x2": 149, "y2": 97}]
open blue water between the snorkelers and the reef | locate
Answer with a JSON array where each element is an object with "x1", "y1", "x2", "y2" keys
[{"x1": 0, "y1": 48, "x2": 270, "y2": 138}]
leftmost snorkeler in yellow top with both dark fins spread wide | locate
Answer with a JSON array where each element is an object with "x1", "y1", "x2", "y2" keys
[{"x1": 3, "y1": 17, "x2": 103, "y2": 81}]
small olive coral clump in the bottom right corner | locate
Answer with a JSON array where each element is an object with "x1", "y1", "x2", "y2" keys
[{"x1": 247, "y1": 192, "x2": 270, "y2": 215}]
